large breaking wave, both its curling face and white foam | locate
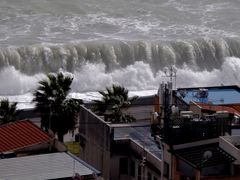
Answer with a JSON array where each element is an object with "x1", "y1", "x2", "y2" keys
[{"x1": 0, "y1": 38, "x2": 240, "y2": 95}]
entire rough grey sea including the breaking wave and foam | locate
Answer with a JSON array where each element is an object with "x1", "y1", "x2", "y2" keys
[{"x1": 0, "y1": 0, "x2": 240, "y2": 108}]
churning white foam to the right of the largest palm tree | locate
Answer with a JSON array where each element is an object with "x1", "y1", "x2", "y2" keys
[{"x1": 73, "y1": 57, "x2": 240, "y2": 92}]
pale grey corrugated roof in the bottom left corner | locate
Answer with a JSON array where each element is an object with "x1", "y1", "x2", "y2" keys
[{"x1": 0, "y1": 152, "x2": 99, "y2": 180}]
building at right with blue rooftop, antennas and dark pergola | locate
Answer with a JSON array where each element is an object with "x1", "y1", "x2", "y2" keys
[{"x1": 152, "y1": 85, "x2": 240, "y2": 180}]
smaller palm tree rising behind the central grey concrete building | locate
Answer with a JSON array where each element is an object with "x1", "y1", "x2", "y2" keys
[{"x1": 93, "y1": 84, "x2": 137, "y2": 123}]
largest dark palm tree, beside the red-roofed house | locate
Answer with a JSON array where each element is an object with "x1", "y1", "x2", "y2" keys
[{"x1": 33, "y1": 72, "x2": 82, "y2": 142}]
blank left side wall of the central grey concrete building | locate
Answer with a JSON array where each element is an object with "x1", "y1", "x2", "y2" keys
[{"x1": 79, "y1": 106, "x2": 111, "y2": 180}]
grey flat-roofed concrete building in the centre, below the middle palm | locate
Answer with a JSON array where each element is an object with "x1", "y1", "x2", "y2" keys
[{"x1": 79, "y1": 103, "x2": 162, "y2": 180}]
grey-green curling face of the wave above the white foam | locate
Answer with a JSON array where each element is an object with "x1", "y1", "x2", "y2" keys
[{"x1": 0, "y1": 38, "x2": 240, "y2": 75}]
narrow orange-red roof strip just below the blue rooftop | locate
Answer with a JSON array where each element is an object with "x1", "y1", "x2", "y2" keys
[{"x1": 195, "y1": 102, "x2": 240, "y2": 115}]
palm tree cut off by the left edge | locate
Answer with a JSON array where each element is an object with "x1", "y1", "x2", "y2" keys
[{"x1": 0, "y1": 99, "x2": 17, "y2": 125}]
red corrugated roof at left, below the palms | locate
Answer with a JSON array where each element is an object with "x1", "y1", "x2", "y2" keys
[{"x1": 0, "y1": 120, "x2": 50, "y2": 152}]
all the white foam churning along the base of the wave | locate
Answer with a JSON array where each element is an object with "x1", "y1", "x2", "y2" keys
[{"x1": 0, "y1": 57, "x2": 240, "y2": 108}]
